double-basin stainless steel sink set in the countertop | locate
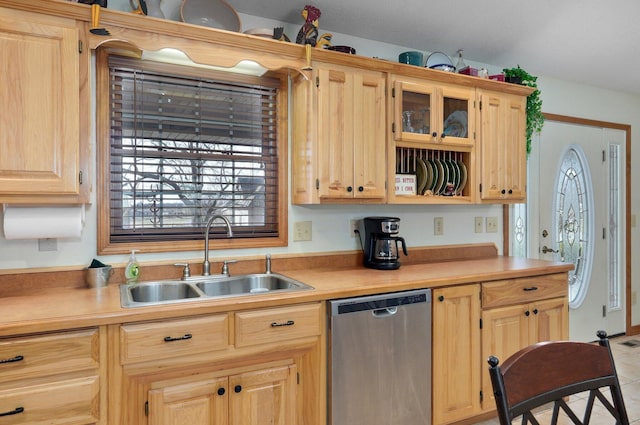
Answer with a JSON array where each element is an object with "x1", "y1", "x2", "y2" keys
[{"x1": 120, "y1": 273, "x2": 313, "y2": 307}]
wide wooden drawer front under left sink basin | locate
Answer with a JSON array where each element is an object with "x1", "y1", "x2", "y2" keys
[{"x1": 120, "y1": 314, "x2": 229, "y2": 364}]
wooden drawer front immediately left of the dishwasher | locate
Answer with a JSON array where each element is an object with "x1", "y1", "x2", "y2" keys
[{"x1": 235, "y1": 304, "x2": 321, "y2": 347}]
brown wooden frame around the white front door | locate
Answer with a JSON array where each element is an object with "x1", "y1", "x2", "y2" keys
[{"x1": 502, "y1": 112, "x2": 640, "y2": 335}]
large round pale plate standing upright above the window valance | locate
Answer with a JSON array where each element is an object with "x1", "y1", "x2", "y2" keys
[{"x1": 180, "y1": 0, "x2": 241, "y2": 32}]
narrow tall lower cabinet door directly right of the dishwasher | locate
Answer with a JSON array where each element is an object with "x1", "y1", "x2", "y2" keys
[{"x1": 432, "y1": 284, "x2": 481, "y2": 425}]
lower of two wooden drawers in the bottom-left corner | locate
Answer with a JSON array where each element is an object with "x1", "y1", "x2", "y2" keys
[{"x1": 0, "y1": 376, "x2": 100, "y2": 425}]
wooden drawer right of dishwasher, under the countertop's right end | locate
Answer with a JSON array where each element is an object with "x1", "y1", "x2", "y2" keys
[{"x1": 482, "y1": 273, "x2": 568, "y2": 308}]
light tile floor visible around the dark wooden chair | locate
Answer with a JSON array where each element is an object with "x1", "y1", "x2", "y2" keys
[{"x1": 476, "y1": 335, "x2": 640, "y2": 425}]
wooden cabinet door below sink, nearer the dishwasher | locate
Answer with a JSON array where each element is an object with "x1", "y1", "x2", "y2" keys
[{"x1": 229, "y1": 364, "x2": 298, "y2": 425}]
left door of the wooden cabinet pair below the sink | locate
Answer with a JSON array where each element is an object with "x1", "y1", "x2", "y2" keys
[{"x1": 149, "y1": 377, "x2": 229, "y2": 425}]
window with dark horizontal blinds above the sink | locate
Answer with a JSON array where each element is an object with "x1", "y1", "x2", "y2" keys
[{"x1": 108, "y1": 56, "x2": 284, "y2": 243}]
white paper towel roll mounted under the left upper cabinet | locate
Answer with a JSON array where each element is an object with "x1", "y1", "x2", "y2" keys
[{"x1": 4, "y1": 205, "x2": 84, "y2": 239}]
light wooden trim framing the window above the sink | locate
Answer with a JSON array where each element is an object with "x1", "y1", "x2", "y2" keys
[{"x1": 96, "y1": 47, "x2": 289, "y2": 255}]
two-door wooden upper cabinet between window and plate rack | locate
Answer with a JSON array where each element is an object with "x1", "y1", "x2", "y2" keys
[{"x1": 292, "y1": 63, "x2": 387, "y2": 204}]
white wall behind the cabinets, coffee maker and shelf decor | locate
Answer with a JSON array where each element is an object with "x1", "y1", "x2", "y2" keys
[{"x1": 0, "y1": 4, "x2": 640, "y2": 288}]
